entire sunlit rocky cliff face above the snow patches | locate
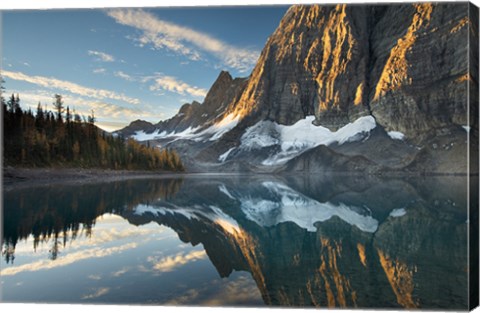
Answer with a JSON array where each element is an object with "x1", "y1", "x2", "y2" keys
[{"x1": 232, "y1": 3, "x2": 471, "y2": 138}]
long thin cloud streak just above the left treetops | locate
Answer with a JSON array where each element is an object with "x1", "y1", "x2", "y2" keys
[{"x1": 2, "y1": 71, "x2": 140, "y2": 104}]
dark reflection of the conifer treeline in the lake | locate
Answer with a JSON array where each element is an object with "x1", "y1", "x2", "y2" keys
[{"x1": 2, "y1": 179, "x2": 183, "y2": 264}]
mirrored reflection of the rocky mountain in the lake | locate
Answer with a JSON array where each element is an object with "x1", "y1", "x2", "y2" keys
[{"x1": 123, "y1": 177, "x2": 468, "y2": 309}]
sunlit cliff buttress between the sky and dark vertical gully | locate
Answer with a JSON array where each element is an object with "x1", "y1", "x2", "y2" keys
[{"x1": 225, "y1": 5, "x2": 370, "y2": 129}]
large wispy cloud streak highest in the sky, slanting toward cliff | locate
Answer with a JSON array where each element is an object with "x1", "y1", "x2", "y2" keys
[{"x1": 107, "y1": 9, "x2": 260, "y2": 72}]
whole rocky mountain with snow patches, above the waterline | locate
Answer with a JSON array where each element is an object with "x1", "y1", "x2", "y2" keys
[{"x1": 119, "y1": 3, "x2": 478, "y2": 173}]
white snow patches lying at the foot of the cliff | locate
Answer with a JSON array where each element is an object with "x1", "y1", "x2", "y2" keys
[{"x1": 132, "y1": 113, "x2": 380, "y2": 166}]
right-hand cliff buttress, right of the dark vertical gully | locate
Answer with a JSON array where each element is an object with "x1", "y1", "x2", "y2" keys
[{"x1": 369, "y1": 3, "x2": 471, "y2": 138}]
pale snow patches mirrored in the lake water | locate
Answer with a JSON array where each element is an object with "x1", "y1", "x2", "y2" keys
[{"x1": 134, "y1": 181, "x2": 380, "y2": 234}]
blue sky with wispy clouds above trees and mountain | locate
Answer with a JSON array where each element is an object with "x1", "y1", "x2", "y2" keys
[{"x1": 1, "y1": 6, "x2": 288, "y2": 130}]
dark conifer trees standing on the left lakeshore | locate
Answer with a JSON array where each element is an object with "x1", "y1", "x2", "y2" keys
[{"x1": 2, "y1": 95, "x2": 184, "y2": 171}]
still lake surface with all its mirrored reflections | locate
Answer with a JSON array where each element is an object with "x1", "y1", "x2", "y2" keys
[{"x1": 0, "y1": 176, "x2": 469, "y2": 310}]
